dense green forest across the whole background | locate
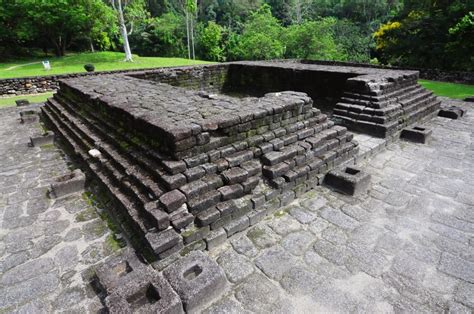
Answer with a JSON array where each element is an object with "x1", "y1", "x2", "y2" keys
[{"x1": 0, "y1": 0, "x2": 474, "y2": 71}]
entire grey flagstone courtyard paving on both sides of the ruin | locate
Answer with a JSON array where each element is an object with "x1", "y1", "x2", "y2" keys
[{"x1": 0, "y1": 97, "x2": 474, "y2": 313}]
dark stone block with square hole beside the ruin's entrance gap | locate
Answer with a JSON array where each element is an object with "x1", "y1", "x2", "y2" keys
[{"x1": 324, "y1": 167, "x2": 370, "y2": 195}]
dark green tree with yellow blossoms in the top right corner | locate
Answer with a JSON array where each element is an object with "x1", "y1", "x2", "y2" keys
[{"x1": 374, "y1": 0, "x2": 474, "y2": 70}]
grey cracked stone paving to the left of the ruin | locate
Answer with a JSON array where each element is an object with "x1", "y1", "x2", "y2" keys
[{"x1": 0, "y1": 108, "x2": 116, "y2": 313}]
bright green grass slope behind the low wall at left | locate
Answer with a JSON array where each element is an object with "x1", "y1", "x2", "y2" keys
[{"x1": 0, "y1": 52, "x2": 209, "y2": 79}]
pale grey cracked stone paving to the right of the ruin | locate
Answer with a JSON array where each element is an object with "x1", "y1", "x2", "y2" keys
[{"x1": 208, "y1": 99, "x2": 474, "y2": 313}]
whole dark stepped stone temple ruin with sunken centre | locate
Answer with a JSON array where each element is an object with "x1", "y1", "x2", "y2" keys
[{"x1": 42, "y1": 61, "x2": 440, "y2": 310}]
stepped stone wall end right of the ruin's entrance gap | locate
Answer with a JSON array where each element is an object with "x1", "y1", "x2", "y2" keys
[{"x1": 333, "y1": 75, "x2": 441, "y2": 137}]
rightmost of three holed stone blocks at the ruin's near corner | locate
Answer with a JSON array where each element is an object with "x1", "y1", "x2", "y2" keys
[{"x1": 163, "y1": 251, "x2": 227, "y2": 312}]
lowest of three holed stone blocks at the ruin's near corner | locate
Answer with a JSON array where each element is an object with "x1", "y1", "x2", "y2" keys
[{"x1": 105, "y1": 273, "x2": 184, "y2": 314}]
